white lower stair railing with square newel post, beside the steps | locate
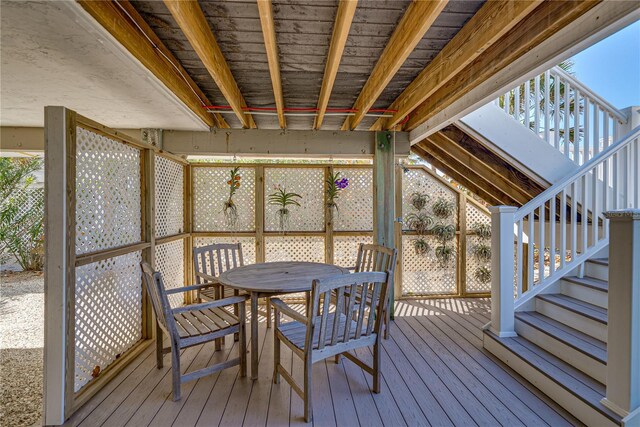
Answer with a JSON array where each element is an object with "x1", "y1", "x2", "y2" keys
[{"x1": 491, "y1": 126, "x2": 640, "y2": 336}]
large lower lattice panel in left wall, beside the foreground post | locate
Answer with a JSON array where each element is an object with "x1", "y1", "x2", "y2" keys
[{"x1": 74, "y1": 252, "x2": 142, "y2": 392}]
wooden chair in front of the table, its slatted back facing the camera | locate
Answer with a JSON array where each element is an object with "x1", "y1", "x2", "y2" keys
[{"x1": 271, "y1": 272, "x2": 391, "y2": 422}]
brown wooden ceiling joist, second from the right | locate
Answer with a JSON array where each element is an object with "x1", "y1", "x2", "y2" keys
[{"x1": 371, "y1": 0, "x2": 542, "y2": 130}]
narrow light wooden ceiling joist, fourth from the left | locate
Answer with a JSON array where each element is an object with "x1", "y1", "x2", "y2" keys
[{"x1": 313, "y1": 0, "x2": 358, "y2": 129}]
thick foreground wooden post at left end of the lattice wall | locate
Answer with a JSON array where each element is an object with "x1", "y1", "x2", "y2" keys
[{"x1": 44, "y1": 107, "x2": 76, "y2": 425}]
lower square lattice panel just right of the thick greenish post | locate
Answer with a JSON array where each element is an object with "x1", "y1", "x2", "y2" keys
[{"x1": 402, "y1": 236, "x2": 457, "y2": 295}]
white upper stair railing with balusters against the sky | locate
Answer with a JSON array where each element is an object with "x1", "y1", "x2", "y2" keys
[{"x1": 494, "y1": 67, "x2": 627, "y2": 166}]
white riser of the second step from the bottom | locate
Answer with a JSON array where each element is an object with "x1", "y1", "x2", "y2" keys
[{"x1": 515, "y1": 319, "x2": 607, "y2": 384}]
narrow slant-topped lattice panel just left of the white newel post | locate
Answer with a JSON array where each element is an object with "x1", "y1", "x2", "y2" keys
[{"x1": 465, "y1": 203, "x2": 491, "y2": 293}]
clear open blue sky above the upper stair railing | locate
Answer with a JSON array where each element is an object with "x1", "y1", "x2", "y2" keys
[{"x1": 572, "y1": 21, "x2": 640, "y2": 109}]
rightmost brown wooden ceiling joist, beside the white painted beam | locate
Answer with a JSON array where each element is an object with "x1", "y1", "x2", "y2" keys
[{"x1": 405, "y1": 1, "x2": 600, "y2": 130}]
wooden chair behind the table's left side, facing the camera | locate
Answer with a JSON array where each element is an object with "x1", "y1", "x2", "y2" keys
[{"x1": 193, "y1": 243, "x2": 271, "y2": 338}]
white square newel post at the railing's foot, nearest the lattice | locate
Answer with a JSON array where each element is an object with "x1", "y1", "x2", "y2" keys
[{"x1": 489, "y1": 206, "x2": 520, "y2": 337}]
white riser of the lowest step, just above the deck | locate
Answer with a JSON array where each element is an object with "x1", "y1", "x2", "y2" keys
[{"x1": 483, "y1": 334, "x2": 619, "y2": 427}]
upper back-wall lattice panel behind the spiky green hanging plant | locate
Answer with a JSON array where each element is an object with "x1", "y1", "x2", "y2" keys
[{"x1": 264, "y1": 168, "x2": 325, "y2": 231}]
